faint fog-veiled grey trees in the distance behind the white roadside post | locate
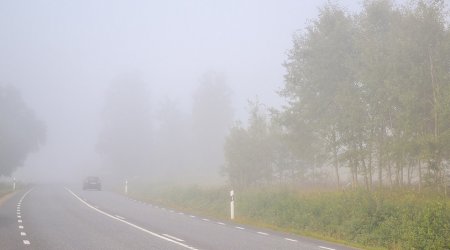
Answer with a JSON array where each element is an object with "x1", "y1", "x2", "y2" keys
[{"x1": 97, "y1": 71, "x2": 233, "y2": 182}]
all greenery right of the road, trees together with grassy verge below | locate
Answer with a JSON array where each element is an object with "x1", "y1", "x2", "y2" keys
[{"x1": 123, "y1": 0, "x2": 450, "y2": 249}]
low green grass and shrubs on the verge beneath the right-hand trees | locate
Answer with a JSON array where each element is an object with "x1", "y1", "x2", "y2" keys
[{"x1": 130, "y1": 185, "x2": 450, "y2": 249}]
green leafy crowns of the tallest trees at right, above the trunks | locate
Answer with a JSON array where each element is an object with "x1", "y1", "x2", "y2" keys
[{"x1": 274, "y1": 0, "x2": 450, "y2": 189}]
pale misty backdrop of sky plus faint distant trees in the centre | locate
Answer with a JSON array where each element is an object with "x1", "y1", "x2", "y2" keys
[{"x1": 0, "y1": 0, "x2": 360, "y2": 184}]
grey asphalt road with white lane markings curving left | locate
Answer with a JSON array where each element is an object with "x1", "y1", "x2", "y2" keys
[{"x1": 0, "y1": 186, "x2": 358, "y2": 250}]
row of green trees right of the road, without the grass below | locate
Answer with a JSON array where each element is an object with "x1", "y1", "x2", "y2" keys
[{"x1": 224, "y1": 0, "x2": 450, "y2": 192}]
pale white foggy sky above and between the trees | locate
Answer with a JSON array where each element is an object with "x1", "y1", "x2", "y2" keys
[{"x1": 0, "y1": 0, "x2": 360, "y2": 182}]
